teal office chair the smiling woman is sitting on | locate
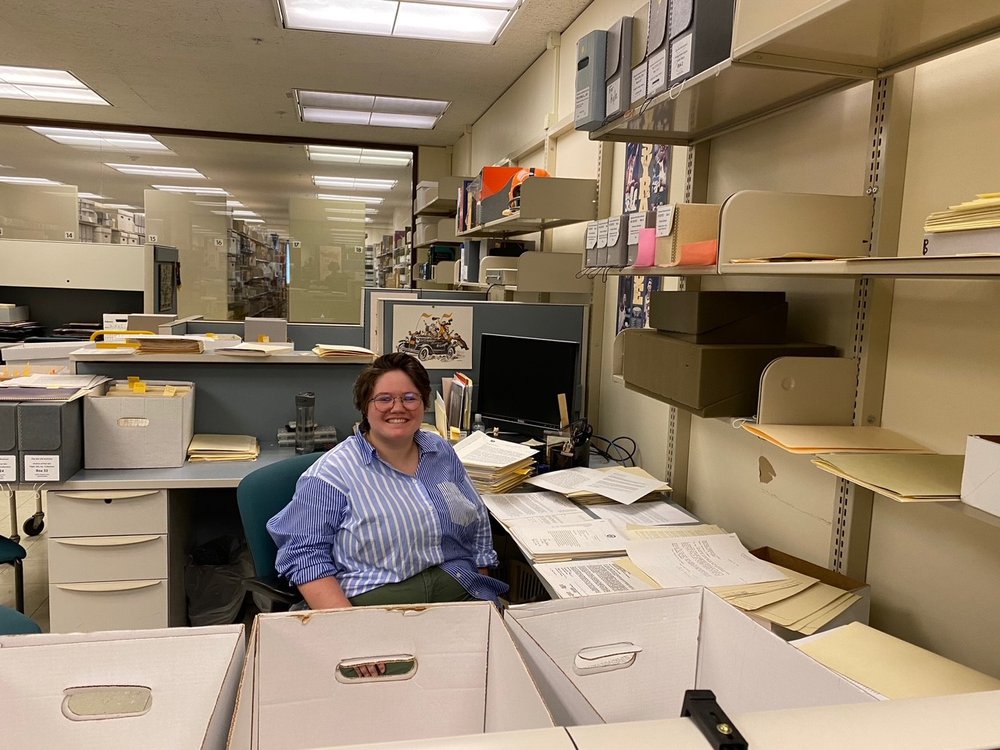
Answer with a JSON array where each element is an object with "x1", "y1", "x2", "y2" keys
[{"x1": 236, "y1": 453, "x2": 323, "y2": 609}]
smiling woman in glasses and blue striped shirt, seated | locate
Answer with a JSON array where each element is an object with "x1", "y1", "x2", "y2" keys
[{"x1": 267, "y1": 353, "x2": 507, "y2": 609}]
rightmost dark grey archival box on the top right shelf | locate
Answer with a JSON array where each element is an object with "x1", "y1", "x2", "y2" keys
[{"x1": 667, "y1": 0, "x2": 735, "y2": 86}]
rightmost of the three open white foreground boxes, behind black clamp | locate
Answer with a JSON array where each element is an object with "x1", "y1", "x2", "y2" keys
[{"x1": 505, "y1": 588, "x2": 875, "y2": 726}]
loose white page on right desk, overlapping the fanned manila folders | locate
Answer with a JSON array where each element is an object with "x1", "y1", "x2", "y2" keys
[{"x1": 625, "y1": 534, "x2": 785, "y2": 588}]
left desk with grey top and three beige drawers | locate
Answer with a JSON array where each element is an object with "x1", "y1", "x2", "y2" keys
[{"x1": 47, "y1": 448, "x2": 295, "y2": 633}]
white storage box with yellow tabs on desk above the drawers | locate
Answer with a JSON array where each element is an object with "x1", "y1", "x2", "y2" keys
[{"x1": 83, "y1": 380, "x2": 194, "y2": 469}]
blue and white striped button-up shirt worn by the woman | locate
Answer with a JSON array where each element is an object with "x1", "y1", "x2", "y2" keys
[{"x1": 267, "y1": 431, "x2": 507, "y2": 601}]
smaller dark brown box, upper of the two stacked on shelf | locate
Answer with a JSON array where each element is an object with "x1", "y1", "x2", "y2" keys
[{"x1": 649, "y1": 292, "x2": 788, "y2": 344}]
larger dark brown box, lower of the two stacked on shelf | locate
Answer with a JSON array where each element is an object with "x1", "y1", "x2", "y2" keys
[{"x1": 621, "y1": 328, "x2": 836, "y2": 417}]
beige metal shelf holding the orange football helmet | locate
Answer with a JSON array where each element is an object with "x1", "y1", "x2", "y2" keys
[{"x1": 455, "y1": 177, "x2": 597, "y2": 237}]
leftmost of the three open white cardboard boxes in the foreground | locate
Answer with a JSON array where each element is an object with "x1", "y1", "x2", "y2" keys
[{"x1": 0, "y1": 625, "x2": 244, "y2": 750}]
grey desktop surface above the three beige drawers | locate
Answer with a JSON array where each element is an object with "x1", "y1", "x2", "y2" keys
[{"x1": 59, "y1": 448, "x2": 295, "y2": 490}]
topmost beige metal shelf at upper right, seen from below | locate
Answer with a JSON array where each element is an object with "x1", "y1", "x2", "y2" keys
[{"x1": 590, "y1": 0, "x2": 1000, "y2": 145}]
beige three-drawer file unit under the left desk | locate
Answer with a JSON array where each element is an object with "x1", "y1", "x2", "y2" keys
[{"x1": 48, "y1": 489, "x2": 185, "y2": 633}]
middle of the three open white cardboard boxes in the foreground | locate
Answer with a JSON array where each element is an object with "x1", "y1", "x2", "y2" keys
[{"x1": 229, "y1": 602, "x2": 553, "y2": 750}]
